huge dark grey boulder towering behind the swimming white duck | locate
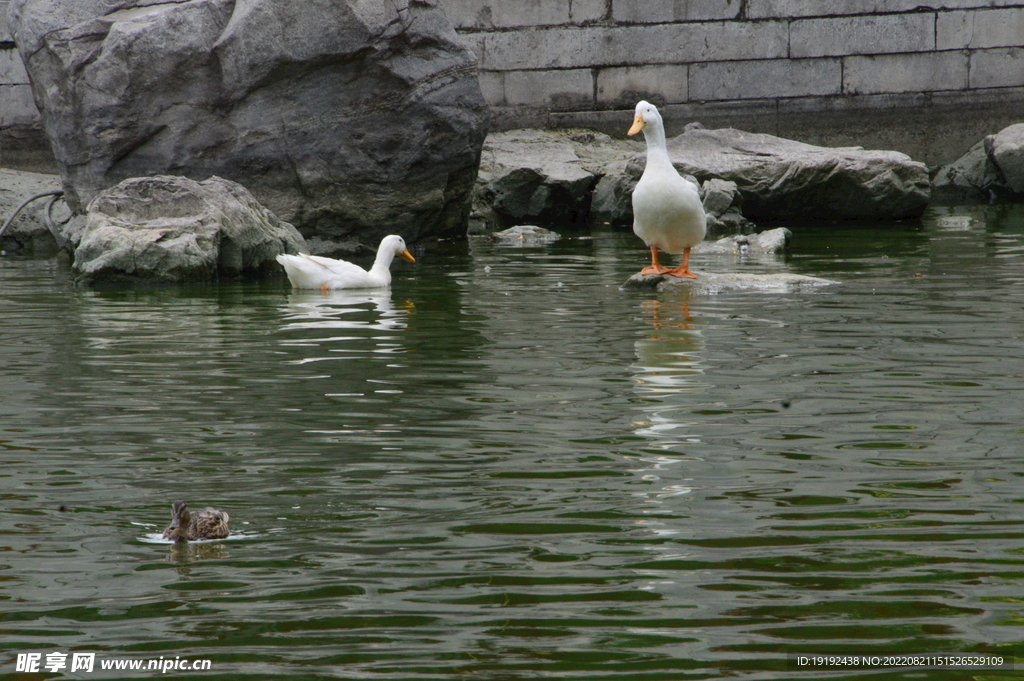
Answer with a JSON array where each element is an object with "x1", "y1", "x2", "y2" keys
[{"x1": 9, "y1": 0, "x2": 488, "y2": 242}]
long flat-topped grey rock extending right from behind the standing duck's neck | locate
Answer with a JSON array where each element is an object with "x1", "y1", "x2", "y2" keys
[{"x1": 627, "y1": 128, "x2": 931, "y2": 221}]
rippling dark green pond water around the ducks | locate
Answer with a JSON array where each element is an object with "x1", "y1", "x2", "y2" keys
[{"x1": 0, "y1": 207, "x2": 1024, "y2": 681}]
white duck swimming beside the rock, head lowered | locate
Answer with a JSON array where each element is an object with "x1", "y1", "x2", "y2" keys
[{"x1": 278, "y1": 235, "x2": 416, "y2": 293}]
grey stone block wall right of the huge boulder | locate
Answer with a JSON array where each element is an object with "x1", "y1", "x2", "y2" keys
[{"x1": 440, "y1": 0, "x2": 1024, "y2": 163}]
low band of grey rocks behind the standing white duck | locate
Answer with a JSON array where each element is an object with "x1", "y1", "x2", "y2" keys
[{"x1": 474, "y1": 126, "x2": 931, "y2": 231}]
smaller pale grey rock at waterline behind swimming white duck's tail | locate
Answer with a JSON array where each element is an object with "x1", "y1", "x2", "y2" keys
[{"x1": 68, "y1": 175, "x2": 305, "y2": 284}]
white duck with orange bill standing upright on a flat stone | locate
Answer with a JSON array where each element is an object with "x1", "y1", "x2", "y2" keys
[{"x1": 628, "y1": 101, "x2": 708, "y2": 279}]
